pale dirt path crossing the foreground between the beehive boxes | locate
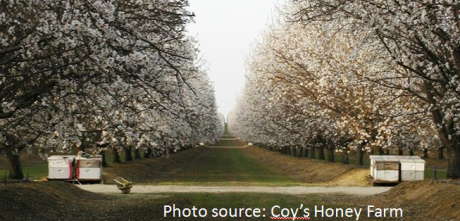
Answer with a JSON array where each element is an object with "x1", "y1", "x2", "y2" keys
[{"x1": 77, "y1": 185, "x2": 391, "y2": 196}]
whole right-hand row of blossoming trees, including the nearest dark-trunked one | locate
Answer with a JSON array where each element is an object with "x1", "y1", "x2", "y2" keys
[{"x1": 229, "y1": 0, "x2": 460, "y2": 178}]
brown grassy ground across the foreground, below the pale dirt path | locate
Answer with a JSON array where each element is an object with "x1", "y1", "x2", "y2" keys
[{"x1": 0, "y1": 181, "x2": 460, "y2": 220}]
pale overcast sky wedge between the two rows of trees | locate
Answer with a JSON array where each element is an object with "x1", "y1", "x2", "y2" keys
[{"x1": 188, "y1": 0, "x2": 284, "y2": 115}]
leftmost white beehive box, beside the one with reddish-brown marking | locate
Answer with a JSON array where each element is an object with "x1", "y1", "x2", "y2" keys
[{"x1": 48, "y1": 155, "x2": 75, "y2": 179}]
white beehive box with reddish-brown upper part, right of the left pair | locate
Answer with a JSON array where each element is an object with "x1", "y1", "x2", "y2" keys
[{"x1": 77, "y1": 158, "x2": 102, "y2": 180}]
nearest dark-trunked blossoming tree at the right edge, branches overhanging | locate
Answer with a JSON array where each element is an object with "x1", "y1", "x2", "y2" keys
[{"x1": 293, "y1": 0, "x2": 460, "y2": 178}]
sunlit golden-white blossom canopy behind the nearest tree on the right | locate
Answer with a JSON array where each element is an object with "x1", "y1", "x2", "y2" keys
[{"x1": 232, "y1": 1, "x2": 430, "y2": 167}]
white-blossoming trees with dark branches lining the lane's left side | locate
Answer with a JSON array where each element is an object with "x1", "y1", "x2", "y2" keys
[{"x1": 0, "y1": 0, "x2": 223, "y2": 178}]
